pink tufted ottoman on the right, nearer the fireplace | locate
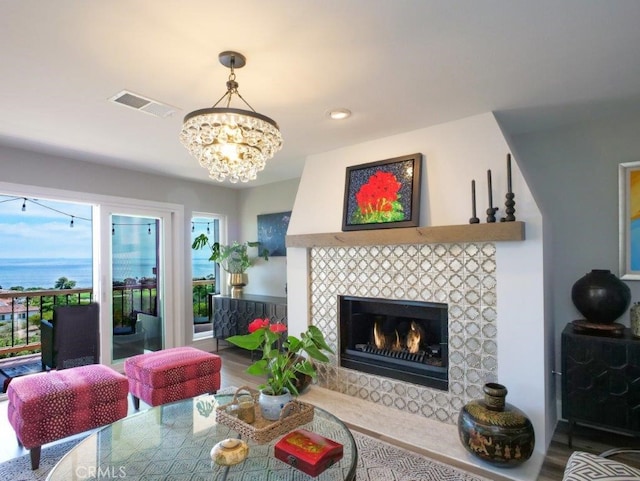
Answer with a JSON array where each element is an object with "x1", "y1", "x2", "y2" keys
[{"x1": 124, "y1": 347, "x2": 222, "y2": 409}]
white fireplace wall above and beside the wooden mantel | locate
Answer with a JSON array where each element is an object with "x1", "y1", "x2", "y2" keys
[{"x1": 287, "y1": 114, "x2": 555, "y2": 452}]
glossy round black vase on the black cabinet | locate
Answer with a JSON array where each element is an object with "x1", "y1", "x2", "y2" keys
[{"x1": 571, "y1": 269, "x2": 631, "y2": 324}]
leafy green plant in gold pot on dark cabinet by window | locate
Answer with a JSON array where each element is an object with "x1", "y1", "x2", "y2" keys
[{"x1": 191, "y1": 234, "x2": 269, "y2": 295}]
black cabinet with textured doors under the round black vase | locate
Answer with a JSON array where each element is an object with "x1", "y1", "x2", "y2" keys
[{"x1": 562, "y1": 324, "x2": 640, "y2": 447}]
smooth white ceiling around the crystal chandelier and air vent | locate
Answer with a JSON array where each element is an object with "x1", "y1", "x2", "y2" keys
[{"x1": 0, "y1": 0, "x2": 640, "y2": 188}]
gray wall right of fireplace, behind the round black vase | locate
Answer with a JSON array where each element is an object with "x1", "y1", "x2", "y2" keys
[{"x1": 511, "y1": 114, "x2": 640, "y2": 386}]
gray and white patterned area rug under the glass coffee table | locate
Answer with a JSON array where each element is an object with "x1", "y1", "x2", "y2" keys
[{"x1": 0, "y1": 431, "x2": 489, "y2": 481}]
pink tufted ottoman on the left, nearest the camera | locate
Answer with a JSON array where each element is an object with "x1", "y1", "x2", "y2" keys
[{"x1": 7, "y1": 364, "x2": 129, "y2": 469}]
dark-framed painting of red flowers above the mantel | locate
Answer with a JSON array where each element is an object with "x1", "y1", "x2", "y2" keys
[{"x1": 342, "y1": 154, "x2": 422, "y2": 231}]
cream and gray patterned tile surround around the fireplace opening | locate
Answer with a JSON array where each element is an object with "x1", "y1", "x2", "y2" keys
[{"x1": 309, "y1": 242, "x2": 498, "y2": 424}]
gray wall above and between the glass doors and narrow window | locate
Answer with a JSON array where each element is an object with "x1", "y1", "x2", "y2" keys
[{"x1": 0, "y1": 146, "x2": 298, "y2": 343}]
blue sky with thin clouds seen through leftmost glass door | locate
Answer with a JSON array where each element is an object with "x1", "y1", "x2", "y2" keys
[{"x1": 0, "y1": 195, "x2": 92, "y2": 259}]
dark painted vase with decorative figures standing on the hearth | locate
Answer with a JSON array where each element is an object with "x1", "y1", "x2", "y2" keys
[{"x1": 458, "y1": 383, "x2": 535, "y2": 467}]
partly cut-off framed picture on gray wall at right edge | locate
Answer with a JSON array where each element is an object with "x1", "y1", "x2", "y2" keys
[{"x1": 618, "y1": 162, "x2": 640, "y2": 280}]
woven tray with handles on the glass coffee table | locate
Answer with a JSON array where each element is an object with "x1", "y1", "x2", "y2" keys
[{"x1": 216, "y1": 386, "x2": 314, "y2": 444}]
